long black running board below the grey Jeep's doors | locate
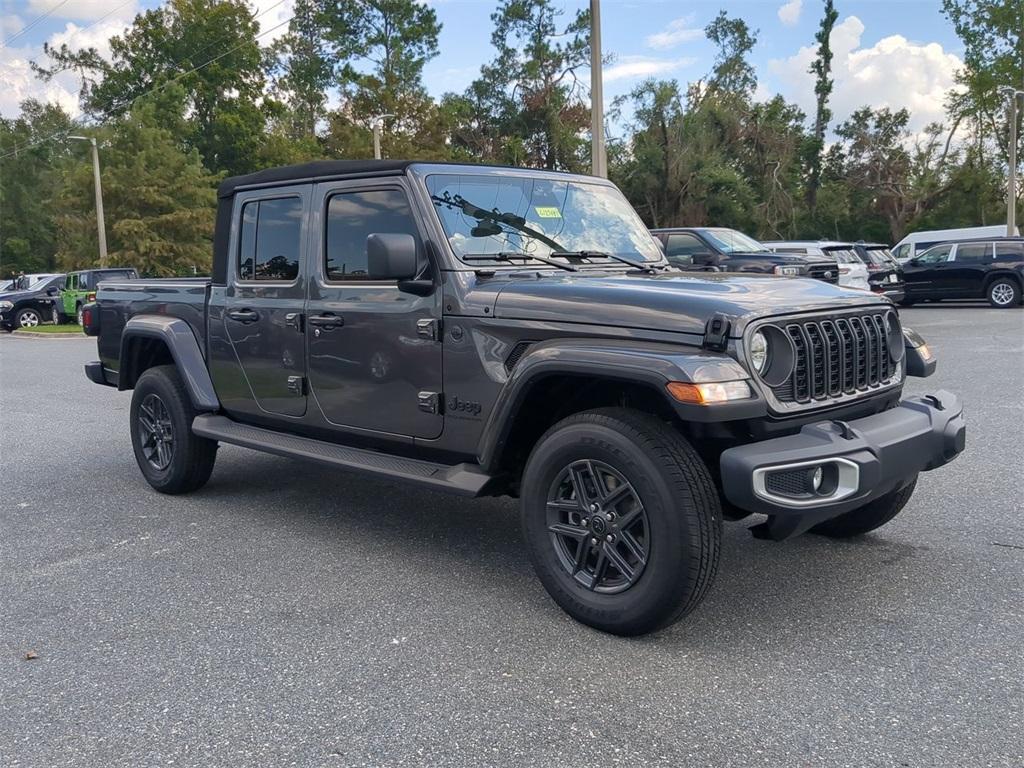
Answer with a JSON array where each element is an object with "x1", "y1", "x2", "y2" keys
[{"x1": 193, "y1": 414, "x2": 492, "y2": 496}]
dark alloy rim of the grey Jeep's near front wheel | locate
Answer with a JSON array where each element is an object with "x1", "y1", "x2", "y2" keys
[{"x1": 547, "y1": 459, "x2": 650, "y2": 594}]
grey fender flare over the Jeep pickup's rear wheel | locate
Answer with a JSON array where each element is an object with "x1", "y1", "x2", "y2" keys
[{"x1": 118, "y1": 314, "x2": 220, "y2": 412}]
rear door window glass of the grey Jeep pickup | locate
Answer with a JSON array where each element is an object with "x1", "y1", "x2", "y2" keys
[{"x1": 239, "y1": 198, "x2": 302, "y2": 282}]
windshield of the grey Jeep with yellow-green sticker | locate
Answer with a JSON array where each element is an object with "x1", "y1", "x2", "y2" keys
[{"x1": 426, "y1": 173, "x2": 663, "y2": 263}]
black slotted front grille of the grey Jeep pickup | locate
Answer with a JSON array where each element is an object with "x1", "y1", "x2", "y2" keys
[{"x1": 772, "y1": 312, "x2": 900, "y2": 404}]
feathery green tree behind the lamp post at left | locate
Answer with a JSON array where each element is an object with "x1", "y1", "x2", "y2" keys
[{"x1": 52, "y1": 104, "x2": 218, "y2": 276}]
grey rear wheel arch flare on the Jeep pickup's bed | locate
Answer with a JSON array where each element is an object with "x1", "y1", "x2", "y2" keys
[{"x1": 118, "y1": 315, "x2": 220, "y2": 413}]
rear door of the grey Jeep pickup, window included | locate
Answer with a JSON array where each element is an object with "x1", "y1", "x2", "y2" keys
[{"x1": 218, "y1": 186, "x2": 309, "y2": 417}]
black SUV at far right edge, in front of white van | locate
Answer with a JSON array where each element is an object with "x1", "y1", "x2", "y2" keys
[{"x1": 902, "y1": 238, "x2": 1024, "y2": 309}]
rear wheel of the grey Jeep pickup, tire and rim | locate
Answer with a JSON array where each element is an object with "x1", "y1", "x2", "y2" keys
[{"x1": 130, "y1": 366, "x2": 217, "y2": 494}]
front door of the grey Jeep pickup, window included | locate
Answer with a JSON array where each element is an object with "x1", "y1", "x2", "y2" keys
[{"x1": 306, "y1": 179, "x2": 442, "y2": 438}]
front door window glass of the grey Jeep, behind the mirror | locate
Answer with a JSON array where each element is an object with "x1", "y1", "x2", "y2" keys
[{"x1": 324, "y1": 189, "x2": 420, "y2": 281}]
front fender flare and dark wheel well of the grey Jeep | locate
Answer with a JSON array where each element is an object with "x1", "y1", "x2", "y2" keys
[{"x1": 477, "y1": 339, "x2": 766, "y2": 479}]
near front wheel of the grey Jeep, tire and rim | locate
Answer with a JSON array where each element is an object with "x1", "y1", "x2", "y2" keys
[{"x1": 521, "y1": 408, "x2": 722, "y2": 635}]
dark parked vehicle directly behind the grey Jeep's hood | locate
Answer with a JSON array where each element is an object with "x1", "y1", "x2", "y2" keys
[{"x1": 651, "y1": 226, "x2": 839, "y2": 284}]
